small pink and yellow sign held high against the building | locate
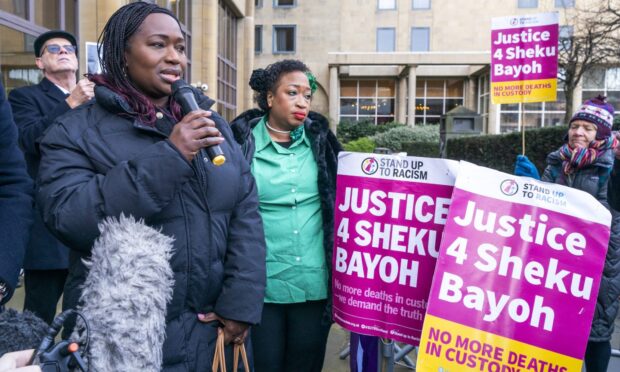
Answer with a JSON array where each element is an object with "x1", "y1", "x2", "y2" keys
[{"x1": 491, "y1": 13, "x2": 558, "y2": 104}]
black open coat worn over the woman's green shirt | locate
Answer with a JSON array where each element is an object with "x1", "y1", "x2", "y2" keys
[{"x1": 230, "y1": 109, "x2": 342, "y2": 323}]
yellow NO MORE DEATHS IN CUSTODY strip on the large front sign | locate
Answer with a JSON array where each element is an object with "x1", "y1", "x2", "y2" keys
[{"x1": 417, "y1": 314, "x2": 582, "y2": 372}]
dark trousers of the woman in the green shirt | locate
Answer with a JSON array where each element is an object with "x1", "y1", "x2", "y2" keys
[{"x1": 252, "y1": 300, "x2": 330, "y2": 372}]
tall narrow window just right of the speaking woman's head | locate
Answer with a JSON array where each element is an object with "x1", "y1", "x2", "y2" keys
[{"x1": 217, "y1": 0, "x2": 238, "y2": 121}]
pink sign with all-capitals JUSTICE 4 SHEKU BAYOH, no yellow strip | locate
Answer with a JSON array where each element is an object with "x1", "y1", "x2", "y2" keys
[{"x1": 332, "y1": 153, "x2": 458, "y2": 345}]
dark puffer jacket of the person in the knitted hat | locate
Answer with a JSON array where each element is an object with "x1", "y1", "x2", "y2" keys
[{"x1": 541, "y1": 150, "x2": 620, "y2": 341}]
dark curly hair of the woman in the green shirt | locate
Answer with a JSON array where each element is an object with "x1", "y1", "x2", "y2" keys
[{"x1": 250, "y1": 59, "x2": 316, "y2": 113}]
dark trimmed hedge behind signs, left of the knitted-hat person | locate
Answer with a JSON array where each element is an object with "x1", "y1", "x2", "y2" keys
[{"x1": 447, "y1": 126, "x2": 568, "y2": 174}]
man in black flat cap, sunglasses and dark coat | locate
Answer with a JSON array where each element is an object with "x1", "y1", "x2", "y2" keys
[{"x1": 9, "y1": 31, "x2": 94, "y2": 323}]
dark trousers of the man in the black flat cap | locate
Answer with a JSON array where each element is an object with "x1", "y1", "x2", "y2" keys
[{"x1": 24, "y1": 269, "x2": 68, "y2": 324}]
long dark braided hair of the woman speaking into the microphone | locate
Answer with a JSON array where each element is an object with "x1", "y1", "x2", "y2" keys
[{"x1": 88, "y1": 1, "x2": 183, "y2": 126}]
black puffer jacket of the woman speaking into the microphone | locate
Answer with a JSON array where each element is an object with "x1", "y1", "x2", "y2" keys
[{"x1": 37, "y1": 87, "x2": 266, "y2": 371}]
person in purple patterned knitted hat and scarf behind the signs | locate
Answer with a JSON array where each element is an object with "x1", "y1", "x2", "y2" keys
[{"x1": 515, "y1": 96, "x2": 620, "y2": 372}]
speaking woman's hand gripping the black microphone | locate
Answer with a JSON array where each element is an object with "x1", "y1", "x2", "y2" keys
[{"x1": 170, "y1": 79, "x2": 226, "y2": 166}]
